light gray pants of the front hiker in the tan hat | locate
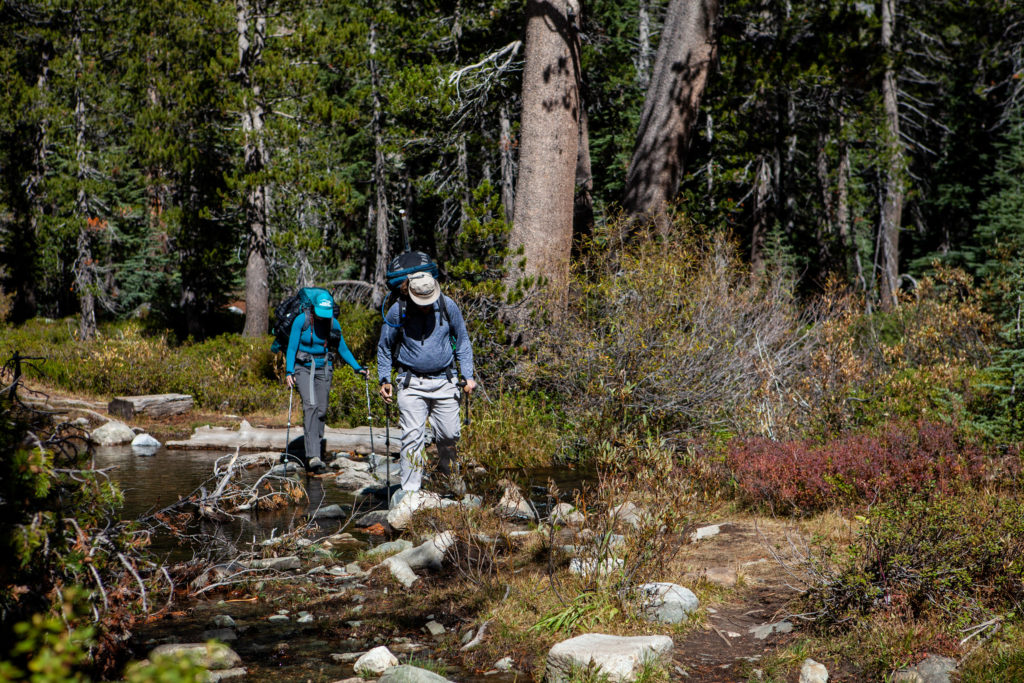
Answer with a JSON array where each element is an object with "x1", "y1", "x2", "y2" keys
[{"x1": 397, "y1": 375, "x2": 462, "y2": 490}]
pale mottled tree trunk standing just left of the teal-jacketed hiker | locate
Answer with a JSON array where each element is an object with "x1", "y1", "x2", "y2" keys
[{"x1": 234, "y1": 0, "x2": 270, "y2": 337}]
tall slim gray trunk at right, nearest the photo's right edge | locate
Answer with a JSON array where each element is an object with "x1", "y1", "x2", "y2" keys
[{"x1": 878, "y1": 0, "x2": 904, "y2": 310}]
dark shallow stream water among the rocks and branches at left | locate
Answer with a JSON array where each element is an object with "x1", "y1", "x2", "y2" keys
[{"x1": 94, "y1": 446, "x2": 580, "y2": 683}]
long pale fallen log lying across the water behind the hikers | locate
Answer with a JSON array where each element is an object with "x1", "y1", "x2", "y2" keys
[{"x1": 165, "y1": 420, "x2": 400, "y2": 454}]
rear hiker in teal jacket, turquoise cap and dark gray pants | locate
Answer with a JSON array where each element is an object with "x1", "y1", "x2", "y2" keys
[{"x1": 285, "y1": 292, "x2": 367, "y2": 467}]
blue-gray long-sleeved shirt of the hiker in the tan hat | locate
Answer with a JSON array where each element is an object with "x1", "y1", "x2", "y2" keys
[{"x1": 377, "y1": 294, "x2": 473, "y2": 382}]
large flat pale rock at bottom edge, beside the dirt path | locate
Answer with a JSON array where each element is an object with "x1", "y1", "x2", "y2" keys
[{"x1": 544, "y1": 633, "x2": 673, "y2": 683}]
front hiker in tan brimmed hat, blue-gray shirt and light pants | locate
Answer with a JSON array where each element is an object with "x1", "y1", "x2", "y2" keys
[{"x1": 377, "y1": 272, "x2": 476, "y2": 492}]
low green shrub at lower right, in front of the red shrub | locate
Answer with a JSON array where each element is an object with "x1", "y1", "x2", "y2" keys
[{"x1": 810, "y1": 494, "x2": 1024, "y2": 630}]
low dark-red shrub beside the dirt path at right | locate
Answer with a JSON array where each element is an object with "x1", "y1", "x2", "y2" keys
[{"x1": 726, "y1": 421, "x2": 995, "y2": 513}]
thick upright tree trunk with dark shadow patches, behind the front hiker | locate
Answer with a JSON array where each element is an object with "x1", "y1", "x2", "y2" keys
[{"x1": 509, "y1": 0, "x2": 580, "y2": 307}]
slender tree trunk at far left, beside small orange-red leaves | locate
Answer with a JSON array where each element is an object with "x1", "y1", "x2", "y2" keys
[{"x1": 72, "y1": 16, "x2": 99, "y2": 341}]
